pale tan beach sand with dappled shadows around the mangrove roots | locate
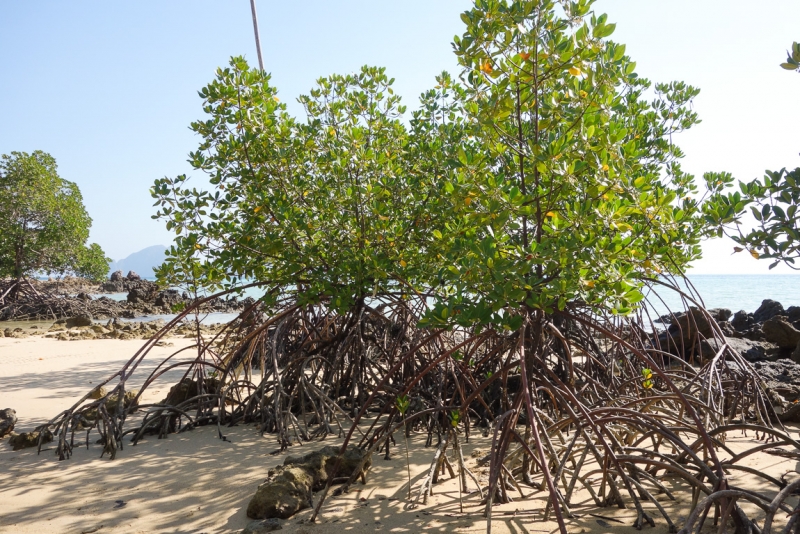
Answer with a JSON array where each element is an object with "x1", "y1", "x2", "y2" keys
[{"x1": 0, "y1": 337, "x2": 798, "y2": 534}]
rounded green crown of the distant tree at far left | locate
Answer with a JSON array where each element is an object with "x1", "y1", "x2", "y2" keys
[{"x1": 0, "y1": 150, "x2": 109, "y2": 279}]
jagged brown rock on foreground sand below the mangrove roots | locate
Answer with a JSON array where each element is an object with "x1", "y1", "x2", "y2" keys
[{"x1": 247, "y1": 445, "x2": 371, "y2": 519}]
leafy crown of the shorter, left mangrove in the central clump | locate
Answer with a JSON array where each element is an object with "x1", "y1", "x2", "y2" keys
[{"x1": 152, "y1": 58, "x2": 421, "y2": 308}]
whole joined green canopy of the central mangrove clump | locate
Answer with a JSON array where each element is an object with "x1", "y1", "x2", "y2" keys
[{"x1": 152, "y1": 0, "x2": 704, "y2": 329}]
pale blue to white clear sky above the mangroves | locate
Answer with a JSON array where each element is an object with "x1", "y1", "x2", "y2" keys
[{"x1": 0, "y1": 0, "x2": 800, "y2": 274}]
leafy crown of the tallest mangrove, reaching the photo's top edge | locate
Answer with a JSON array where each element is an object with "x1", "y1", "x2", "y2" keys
[{"x1": 423, "y1": 1, "x2": 702, "y2": 329}]
